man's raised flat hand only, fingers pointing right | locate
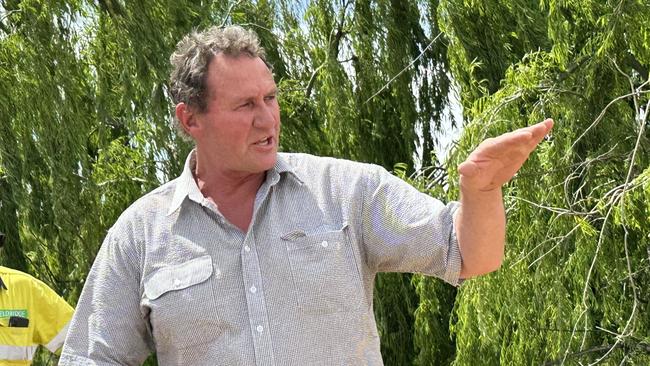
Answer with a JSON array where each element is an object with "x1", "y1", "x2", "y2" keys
[{"x1": 458, "y1": 119, "x2": 553, "y2": 192}]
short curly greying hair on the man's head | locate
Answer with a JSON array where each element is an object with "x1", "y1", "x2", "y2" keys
[{"x1": 169, "y1": 25, "x2": 271, "y2": 139}]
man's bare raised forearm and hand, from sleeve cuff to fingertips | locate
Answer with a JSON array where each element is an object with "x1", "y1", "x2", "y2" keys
[{"x1": 454, "y1": 119, "x2": 553, "y2": 278}]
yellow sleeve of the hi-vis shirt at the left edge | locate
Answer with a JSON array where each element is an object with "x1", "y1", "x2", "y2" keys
[{"x1": 32, "y1": 280, "x2": 74, "y2": 352}]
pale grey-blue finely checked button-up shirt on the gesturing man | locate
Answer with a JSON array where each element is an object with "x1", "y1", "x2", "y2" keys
[{"x1": 59, "y1": 153, "x2": 461, "y2": 366}]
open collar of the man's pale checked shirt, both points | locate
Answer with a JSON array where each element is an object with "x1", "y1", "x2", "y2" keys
[{"x1": 167, "y1": 150, "x2": 303, "y2": 216}]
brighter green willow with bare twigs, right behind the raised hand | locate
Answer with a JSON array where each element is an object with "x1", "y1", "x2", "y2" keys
[{"x1": 410, "y1": 0, "x2": 650, "y2": 365}]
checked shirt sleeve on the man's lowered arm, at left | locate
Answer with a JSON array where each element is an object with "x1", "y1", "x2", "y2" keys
[{"x1": 59, "y1": 229, "x2": 153, "y2": 365}]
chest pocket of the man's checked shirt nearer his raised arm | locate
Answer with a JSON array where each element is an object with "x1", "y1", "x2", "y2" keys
[{"x1": 282, "y1": 226, "x2": 365, "y2": 314}]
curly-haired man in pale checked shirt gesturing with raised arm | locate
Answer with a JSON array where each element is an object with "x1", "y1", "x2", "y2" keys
[{"x1": 60, "y1": 27, "x2": 552, "y2": 365}]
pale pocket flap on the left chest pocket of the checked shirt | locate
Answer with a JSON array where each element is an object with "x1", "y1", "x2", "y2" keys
[{"x1": 144, "y1": 255, "x2": 212, "y2": 300}]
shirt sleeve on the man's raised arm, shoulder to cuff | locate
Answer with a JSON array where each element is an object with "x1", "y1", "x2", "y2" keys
[{"x1": 363, "y1": 167, "x2": 461, "y2": 286}]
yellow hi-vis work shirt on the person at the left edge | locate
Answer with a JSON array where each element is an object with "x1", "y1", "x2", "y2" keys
[{"x1": 0, "y1": 266, "x2": 74, "y2": 366}]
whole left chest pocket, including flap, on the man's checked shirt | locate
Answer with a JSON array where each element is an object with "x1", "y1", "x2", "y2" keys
[{"x1": 144, "y1": 255, "x2": 224, "y2": 349}]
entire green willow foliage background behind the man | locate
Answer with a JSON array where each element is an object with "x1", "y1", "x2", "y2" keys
[{"x1": 0, "y1": 0, "x2": 650, "y2": 365}]
